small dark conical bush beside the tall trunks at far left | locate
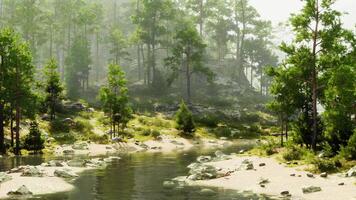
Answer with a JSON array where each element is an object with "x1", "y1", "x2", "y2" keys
[{"x1": 24, "y1": 122, "x2": 44, "y2": 153}]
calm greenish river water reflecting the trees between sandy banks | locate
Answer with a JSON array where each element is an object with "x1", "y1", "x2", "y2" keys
[{"x1": 0, "y1": 141, "x2": 276, "y2": 200}]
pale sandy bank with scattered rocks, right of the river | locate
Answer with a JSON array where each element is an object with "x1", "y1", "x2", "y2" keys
[{"x1": 187, "y1": 156, "x2": 356, "y2": 200}]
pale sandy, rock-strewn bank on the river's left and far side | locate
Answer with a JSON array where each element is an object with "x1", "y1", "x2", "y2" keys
[{"x1": 0, "y1": 135, "x2": 233, "y2": 198}]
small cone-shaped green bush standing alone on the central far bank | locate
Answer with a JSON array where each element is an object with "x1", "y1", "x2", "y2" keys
[{"x1": 176, "y1": 101, "x2": 195, "y2": 136}]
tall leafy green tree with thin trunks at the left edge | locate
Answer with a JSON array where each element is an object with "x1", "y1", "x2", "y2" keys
[{"x1": 0, "y1": 28, "x2": 36, "y2": 154}]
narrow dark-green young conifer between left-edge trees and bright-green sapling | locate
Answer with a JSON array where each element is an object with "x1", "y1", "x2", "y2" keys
[{"x1": 44, "y1": 59, "x2": 63, "y2": 120}]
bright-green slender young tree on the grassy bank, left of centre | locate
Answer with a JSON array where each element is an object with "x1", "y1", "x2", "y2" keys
[{"x1": 99, "y1": 64, "x2": 132, "y2": 138}]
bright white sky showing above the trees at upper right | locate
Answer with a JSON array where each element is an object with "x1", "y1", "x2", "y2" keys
[{"x1": 250, "y1": 0, "x2": 356, "y2": 29}]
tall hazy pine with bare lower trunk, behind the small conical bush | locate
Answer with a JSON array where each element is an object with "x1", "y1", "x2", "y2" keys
[{"x1": 165, "y1": 22, "x2": 213, "y2": 103}]
